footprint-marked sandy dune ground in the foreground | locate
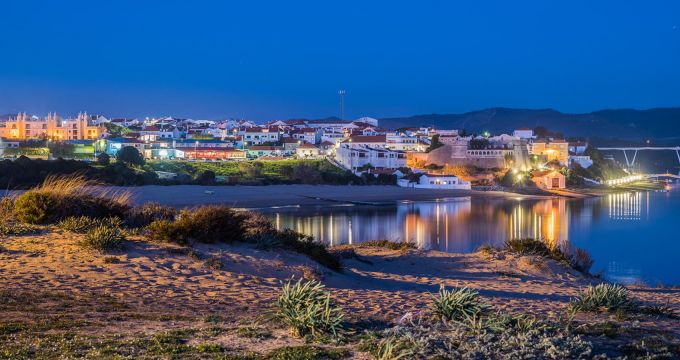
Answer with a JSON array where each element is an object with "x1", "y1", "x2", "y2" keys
[{"x1": 0, "y1": 230, "x2": 680, "y2": 359}]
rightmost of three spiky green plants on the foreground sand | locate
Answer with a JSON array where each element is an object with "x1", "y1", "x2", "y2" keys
[{"x1": 569, "y1": 283, "x2": 638, "y2": 312}]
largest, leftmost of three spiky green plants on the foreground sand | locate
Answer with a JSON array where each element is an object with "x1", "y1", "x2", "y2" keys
[{"x1": 274, "y1": 279, "x2": 343, "y2": 336}]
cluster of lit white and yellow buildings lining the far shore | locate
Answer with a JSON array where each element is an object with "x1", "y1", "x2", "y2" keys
[{"x1": 0, "y1": 113, "x2": 592, "y2": 188}]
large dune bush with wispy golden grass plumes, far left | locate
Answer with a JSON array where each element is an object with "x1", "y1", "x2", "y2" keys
[{"x1": 14, "y1": 176, "x2": 130, "y2": 224}]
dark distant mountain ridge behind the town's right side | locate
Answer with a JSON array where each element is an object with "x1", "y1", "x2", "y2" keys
[{"x1": 380, "y1": 107, "x2": 680, "y2": 141}]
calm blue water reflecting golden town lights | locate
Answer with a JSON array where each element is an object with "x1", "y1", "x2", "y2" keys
[{"x1": 266, "y1": 187, "x2": 680, "y2": 285}]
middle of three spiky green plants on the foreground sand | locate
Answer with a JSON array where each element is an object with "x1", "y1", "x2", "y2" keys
[{"x1": 430, "y1": 285, "x2": 489, "y2": 320}]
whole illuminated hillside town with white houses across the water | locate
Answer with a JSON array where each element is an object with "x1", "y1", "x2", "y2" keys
[{"x1": 0, "y1": 113, "x2": 626, "y2": 191}]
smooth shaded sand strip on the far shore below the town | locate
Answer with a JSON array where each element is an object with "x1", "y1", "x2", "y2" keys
[{"x1": 111, "y1": 185, "x2": 546, "y2": 208}]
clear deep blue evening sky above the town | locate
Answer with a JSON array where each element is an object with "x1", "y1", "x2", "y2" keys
[{"x1": 0, "y1": 0, "x2": 680, "y2": 120}]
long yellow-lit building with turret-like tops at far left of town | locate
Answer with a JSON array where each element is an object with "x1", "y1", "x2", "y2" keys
[{"x1": 0, "y1": 113, "x2": 104, "y2": 140}]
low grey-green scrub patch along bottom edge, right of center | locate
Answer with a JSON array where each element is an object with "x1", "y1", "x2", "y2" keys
[{"x1": 362, "y1": 312, "x2": 593, "y2": 359}]
